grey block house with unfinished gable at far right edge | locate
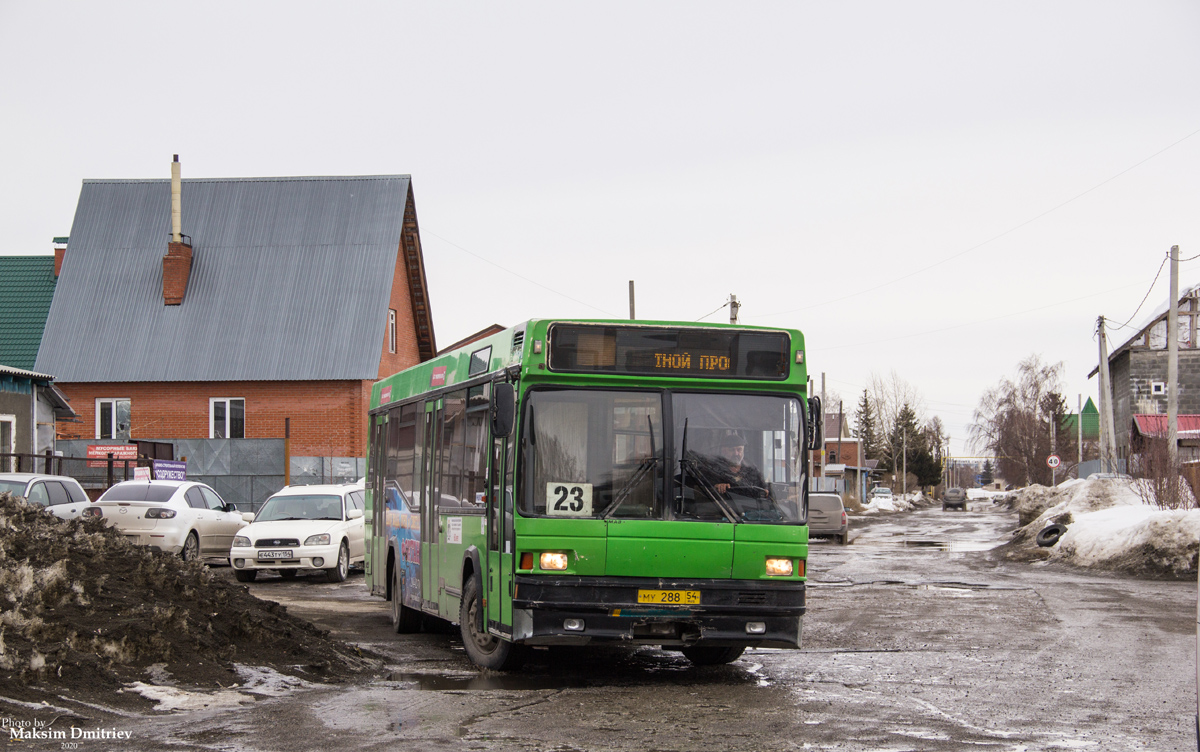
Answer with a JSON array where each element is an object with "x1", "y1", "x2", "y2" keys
[{"x1": 1088, "y1": 284, "x2": 1200, "y2": 458}]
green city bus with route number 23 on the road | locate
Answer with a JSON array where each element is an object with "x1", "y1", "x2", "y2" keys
[{"x1": 366, "y1": 319, "x2": 821, "y2": 670}]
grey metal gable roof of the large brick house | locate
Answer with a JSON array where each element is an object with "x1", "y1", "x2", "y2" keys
[{"x1": 36, "y1": 175, "x2": 409, "y2": 383}]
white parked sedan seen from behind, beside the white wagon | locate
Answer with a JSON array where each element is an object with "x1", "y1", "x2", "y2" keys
[{"x1": 84, "y1": 481, "x2": 248, "y2": 561}]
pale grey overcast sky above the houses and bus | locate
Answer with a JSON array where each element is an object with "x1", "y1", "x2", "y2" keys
[{"x1": 0, "y1": 0, "x2": 1200, "y2": 456}]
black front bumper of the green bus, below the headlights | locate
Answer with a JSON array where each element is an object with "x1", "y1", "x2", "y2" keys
[{"x1": 512, "y1": 576, "x2": 805, "y2": 648}]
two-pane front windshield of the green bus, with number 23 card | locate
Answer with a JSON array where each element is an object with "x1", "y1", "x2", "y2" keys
[{"x1": 522, "y1": 390, "x2": 805, "y2": 524}]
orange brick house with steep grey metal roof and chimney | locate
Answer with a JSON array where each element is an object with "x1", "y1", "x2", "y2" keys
[{"x1": 37, "y1": 166, "x2": 437, "y2": 501}]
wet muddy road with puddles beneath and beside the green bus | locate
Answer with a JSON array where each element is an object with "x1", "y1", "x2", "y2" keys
[{"x1": 4, "y1": 503, "x2": 1196, "y2": 752}]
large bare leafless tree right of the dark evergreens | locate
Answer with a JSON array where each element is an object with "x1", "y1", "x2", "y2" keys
[{"x1": 971, "y1": 355, "x2": 1075, "y2": 486}]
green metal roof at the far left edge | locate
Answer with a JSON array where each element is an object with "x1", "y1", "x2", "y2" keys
[{"x1": 0, "y1": 255, "x2": 54, "y2": 369}]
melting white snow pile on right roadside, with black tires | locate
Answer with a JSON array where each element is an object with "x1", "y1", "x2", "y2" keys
[{"x1": 1006, "y1": 479, "x2": 1200, "y2": 577}]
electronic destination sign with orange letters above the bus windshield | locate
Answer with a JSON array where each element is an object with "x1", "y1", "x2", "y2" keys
[{"x1": 550, "y1": 324, "x2": 791, "y2": 380}]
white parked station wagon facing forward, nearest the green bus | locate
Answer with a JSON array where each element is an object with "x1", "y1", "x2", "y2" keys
[{"x1": 229, "y1": 483, "x2": 366, "y2": 582}]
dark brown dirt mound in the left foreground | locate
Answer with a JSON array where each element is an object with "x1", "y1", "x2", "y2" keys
[{"x1": 0, "y1": 493, "x2": 374, "y2": 699}]
